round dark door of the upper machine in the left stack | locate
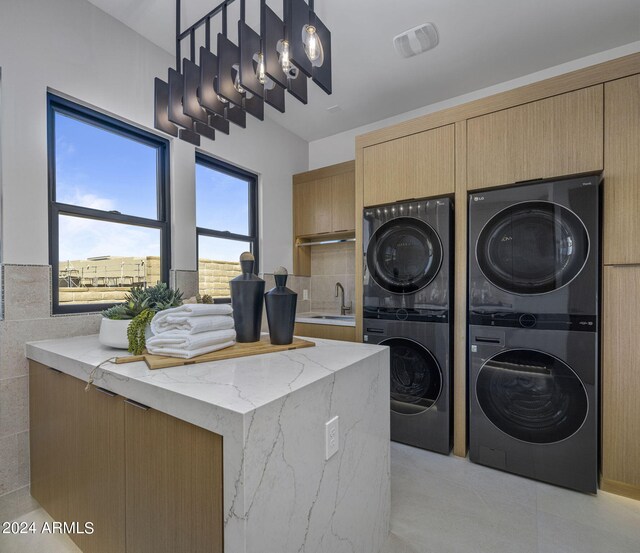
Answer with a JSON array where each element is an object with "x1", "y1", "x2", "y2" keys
[{"x1": 367, "y1": 217, "x2": 442, "y2": 294}]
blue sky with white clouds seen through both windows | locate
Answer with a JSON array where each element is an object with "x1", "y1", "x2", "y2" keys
[{"x1": 55, "y1": 113, "x2": 248, "y2": 264}]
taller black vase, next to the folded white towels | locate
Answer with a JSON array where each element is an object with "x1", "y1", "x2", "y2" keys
[{"x1": 229, "y1": 253, "x2": 264, "y2": 343}]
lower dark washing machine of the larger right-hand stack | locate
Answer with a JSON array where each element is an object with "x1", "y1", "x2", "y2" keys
[{"x1": 469, "y1": 326, "x2": 598, "y2": 493}]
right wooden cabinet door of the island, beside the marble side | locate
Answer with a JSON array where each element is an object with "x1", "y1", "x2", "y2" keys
[{"x1": 125, "y1": 403, "x2": 223, "y2": 553}]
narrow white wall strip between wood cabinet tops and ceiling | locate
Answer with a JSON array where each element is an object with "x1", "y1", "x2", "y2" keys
[{"x1": 309, "y1": 41, "x2": 640, "y2": 169}]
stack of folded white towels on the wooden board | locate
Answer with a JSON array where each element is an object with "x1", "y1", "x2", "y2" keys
[{"x1": 147, "y1": 303, "x2": 236, "y2": 359}]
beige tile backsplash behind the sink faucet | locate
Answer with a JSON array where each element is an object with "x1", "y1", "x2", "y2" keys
[{"x1": 309, "y1": 242, "x2": 356, "y2": 314}]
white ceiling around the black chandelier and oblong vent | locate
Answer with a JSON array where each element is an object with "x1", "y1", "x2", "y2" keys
[{"x1": 88, "y1": 0, "x2": 640, "y2": 141}]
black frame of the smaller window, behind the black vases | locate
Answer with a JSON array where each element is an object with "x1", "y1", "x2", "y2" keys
[{"x1": 195, "y1": 151, "x2": 260, "y2": 286}]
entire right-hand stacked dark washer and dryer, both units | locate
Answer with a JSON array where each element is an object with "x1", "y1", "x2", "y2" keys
[{"x1": 469, "y1": 175, "x2": 601, "y2": 493}]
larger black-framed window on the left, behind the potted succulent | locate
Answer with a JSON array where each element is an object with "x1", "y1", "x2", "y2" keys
[{"x1": 48, "y1": 94, "x2": 170, "y2": 313}]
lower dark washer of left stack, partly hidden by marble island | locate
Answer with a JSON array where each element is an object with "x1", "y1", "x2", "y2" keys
[{"x1": 363, "y1": 318, "x2": 453, "y2": 455}]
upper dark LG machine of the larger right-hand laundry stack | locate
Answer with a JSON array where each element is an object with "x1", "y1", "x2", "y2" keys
[{"x1": 469, "y1": 175, "x2": 601, "y2": 330}]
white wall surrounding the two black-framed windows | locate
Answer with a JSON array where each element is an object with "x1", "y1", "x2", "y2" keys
[{"x1": 0, "y1": 0, "x2": 308, "y2": 270}]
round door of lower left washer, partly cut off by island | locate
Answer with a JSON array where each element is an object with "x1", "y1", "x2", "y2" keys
[{"x1": 380, "y1": 338, "x2": 442, "y2": 415}]
